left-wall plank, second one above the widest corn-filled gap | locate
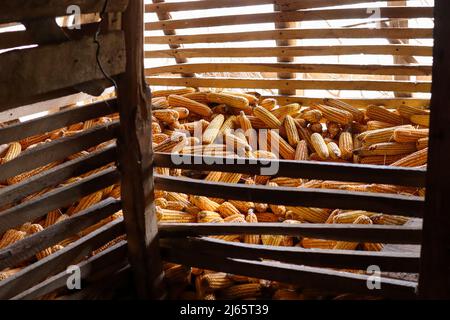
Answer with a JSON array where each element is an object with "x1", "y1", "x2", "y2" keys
[{"x1": 0, "y1": 145, "x2": 117, "y2": 207}]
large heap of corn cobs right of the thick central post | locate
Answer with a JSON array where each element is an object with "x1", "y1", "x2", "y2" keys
[{"x1": 152, "y1": 88, "x2": 429, "y2": 299}]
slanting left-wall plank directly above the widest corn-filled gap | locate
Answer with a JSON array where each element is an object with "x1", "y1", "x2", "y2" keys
[{"x1": 0, "y1": 168, "x2": 119, "y2": 233}]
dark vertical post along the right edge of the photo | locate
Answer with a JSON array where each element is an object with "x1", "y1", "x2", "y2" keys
[{"x1": 419, "y1": 0, "x2": 450, "y2": 299}]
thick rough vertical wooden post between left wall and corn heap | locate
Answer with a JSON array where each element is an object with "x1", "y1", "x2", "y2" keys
[{"x1": 118, "y1": 0, "x2": 164, "y2": 299}]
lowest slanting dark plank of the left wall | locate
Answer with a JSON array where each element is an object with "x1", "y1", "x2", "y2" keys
[{"x1": 11, "y1": 241, "x2": 127, "y2": 300}]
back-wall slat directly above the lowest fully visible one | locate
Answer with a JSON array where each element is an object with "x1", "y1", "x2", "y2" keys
[{"x1": 145, "y1": 62, "x2": 431, "y2": 76}]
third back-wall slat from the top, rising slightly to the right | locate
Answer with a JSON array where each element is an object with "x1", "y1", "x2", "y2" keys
[{"x1": 145, "y1": 28, "x2": 433, "y2": 44}]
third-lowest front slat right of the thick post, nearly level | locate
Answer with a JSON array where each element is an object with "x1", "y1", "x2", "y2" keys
[{"x1": 158, "y1": 223, "x2": 422, "y2": 244}]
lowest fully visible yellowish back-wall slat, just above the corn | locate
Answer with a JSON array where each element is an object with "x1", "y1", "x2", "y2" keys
[{"x1": 146, "y1": 77, "x2": 431, "y2": 92}]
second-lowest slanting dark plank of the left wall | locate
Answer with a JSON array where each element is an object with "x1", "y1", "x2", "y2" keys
[{"x1": 0, "y1": 218, "x2": 124, "y2": 299}]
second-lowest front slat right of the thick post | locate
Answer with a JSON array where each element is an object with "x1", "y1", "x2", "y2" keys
[{"x1": 160, "y1": 238, "x2": 420, "y2": 273}]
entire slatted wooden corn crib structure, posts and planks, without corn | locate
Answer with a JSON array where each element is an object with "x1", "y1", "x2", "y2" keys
[{"x1": 0, "y1": 0, "x2": 450, "y2": 299}]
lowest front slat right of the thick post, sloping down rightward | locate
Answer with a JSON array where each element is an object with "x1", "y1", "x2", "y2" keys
[{"x1": 162, "y1": 249, "x2": 417, "y2": 299}]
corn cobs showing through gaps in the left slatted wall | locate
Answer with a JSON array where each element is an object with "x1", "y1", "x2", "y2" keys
[{"x1": 0, "y1": 110, "x2": 123, "y2": 292}]
